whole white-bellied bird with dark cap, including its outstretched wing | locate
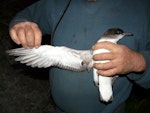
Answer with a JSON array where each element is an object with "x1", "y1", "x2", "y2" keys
[{"x1": 7, "y1": 28, "x2": 132, "y2": 102}]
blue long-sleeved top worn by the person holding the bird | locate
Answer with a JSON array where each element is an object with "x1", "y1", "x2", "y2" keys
[{"x1": 10, "y1": 0, "x2": 150, "y2": 113}]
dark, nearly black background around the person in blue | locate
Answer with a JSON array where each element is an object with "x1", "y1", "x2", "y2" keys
[{"x1": 0, "y1": 0, "x2": 150, "y2": 113}]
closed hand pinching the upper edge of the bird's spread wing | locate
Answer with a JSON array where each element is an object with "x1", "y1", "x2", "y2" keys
[{"x1": 9, "y1": 22, "x2": 42, "y2": 48}]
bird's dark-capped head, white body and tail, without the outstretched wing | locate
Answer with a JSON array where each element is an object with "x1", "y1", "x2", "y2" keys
[{"x1": 93, "y1": 28, "x2": 133, "y2": 102}]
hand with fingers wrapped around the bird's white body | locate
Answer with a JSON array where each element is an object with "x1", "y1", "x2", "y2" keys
[{"x1": 93, "y1": 42, "x2": 146, "y2": 76}]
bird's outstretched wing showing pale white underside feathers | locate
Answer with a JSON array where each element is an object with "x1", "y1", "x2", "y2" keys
[{"x1": 7, "y1": 45, "x2": 91, "y2": 71}]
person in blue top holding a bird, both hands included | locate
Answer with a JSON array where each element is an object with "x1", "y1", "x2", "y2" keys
[{"x1": 9, "y1": 0, "x2": 150, "y2": 113}]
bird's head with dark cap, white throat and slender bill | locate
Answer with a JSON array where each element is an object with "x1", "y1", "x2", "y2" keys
[{"x1": 98, "y1": 28, "x2": 133, "y2": 43}]
